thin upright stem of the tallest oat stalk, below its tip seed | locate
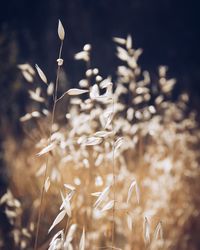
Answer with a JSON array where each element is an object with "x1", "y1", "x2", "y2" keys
[{"x1": 34, "y1": 40, "x2": 63, "y2": 250}]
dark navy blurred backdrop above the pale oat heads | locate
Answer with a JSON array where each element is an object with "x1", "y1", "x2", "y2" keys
[{"x1": 0, "y1": 0, "x2": 200, "y2": 126}]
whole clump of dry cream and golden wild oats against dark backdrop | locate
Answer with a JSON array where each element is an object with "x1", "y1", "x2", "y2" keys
[{"x1": 1, "y1": 21, "x2": 200, "y2": 250}]
